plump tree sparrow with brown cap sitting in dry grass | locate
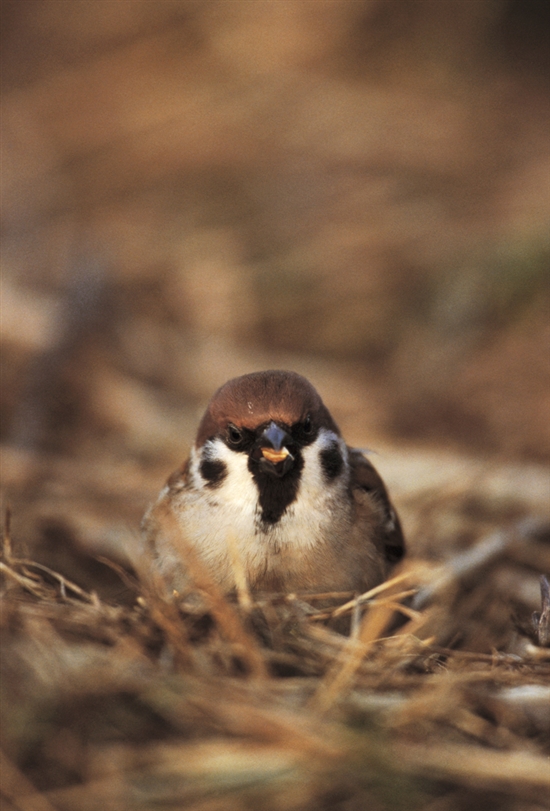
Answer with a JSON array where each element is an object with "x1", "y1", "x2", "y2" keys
[{"x1": 143, "y1": 371, "x2": 405, "y2": 592}]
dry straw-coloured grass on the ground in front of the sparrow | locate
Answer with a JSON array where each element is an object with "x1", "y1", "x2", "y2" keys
[{"x1": 1, "y1": 508, "x2": 550, "y2": 811}]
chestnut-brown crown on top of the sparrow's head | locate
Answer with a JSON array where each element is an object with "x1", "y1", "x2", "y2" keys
[{"x1": 196, "y1": 370, "x2": 340, "y2": 447}]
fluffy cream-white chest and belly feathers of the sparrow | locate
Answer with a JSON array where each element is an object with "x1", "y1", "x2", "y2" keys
[{"x1": 167, "y1": 440, "x2": 351, "y2": 584}]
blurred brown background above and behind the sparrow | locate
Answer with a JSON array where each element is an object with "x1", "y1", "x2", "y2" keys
[{"x1": 0, "y1": 0, "x2": 550, "y2": 572}]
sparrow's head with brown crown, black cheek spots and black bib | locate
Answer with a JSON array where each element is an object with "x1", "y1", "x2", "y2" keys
[{"x1": 195, "y1": 371, "x2": 344, "y2": 522}]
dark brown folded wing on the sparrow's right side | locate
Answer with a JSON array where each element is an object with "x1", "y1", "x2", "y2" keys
[{"x1": 349, "y1": 448, "x2": 405, "y2": 564}]
